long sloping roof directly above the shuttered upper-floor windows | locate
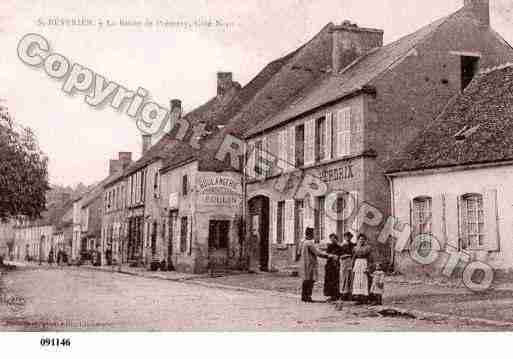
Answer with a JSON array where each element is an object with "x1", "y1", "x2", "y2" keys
[{"x1": 246, "y1": 13, "x2": 450, "y2": 137}]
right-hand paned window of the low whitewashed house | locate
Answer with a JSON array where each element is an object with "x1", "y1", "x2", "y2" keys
[{"x1": 460, "y1": 194, "x2": 485, "y2": 249}]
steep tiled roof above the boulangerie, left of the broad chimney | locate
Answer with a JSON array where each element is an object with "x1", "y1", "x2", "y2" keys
[{"x1": 164, "y1": 24, "x2": 340, "y2": 171}]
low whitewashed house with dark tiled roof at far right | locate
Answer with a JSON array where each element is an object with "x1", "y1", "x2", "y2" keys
[{"x1": 388, "y1": 64, "x2": 513, "y2": 274}]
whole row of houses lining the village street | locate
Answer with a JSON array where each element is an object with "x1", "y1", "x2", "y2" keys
[{"x1": 9, "y1": 0, "x2": 513, "y2": 278}]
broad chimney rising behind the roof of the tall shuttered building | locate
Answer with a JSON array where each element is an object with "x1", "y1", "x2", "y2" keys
[{"x1": 331, "y1": 20, "x2": 383, "y2": 73}]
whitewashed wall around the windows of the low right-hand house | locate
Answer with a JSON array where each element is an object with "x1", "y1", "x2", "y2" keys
[{"x1": 393, "y1": 165, "x2": 513, "y2": 269}]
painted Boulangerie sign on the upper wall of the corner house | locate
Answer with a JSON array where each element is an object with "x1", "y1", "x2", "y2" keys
[{"x1": 197, "y1": 174, "x2": 242, "y2": 209}]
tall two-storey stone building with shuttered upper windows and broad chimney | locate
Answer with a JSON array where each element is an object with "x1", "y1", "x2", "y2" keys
[{"x1": 241, "y1": 0, "x2": 513, "y2": 269}]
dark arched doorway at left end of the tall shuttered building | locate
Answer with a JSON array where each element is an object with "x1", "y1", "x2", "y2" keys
[{"x1": 249, "y1": 196, "x2": 270, "y2": 271}]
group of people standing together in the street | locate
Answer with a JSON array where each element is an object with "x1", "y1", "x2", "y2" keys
[{"x1": 300, "y1": 228, "x2": 385, "y2": 305}]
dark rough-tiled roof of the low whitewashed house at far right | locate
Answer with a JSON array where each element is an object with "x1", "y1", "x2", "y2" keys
[{"x1": 389, "y1": 65, "x2": 513, "y2": 172}]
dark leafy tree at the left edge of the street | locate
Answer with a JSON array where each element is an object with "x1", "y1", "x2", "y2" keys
[{"x1": 0, "y1": 103, "x2": 49, "y2": 221}]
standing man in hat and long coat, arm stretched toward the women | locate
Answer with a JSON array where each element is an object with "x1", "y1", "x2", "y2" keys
[{"x1": 301, "y1": 228, "x2": 337, "y2": 303}]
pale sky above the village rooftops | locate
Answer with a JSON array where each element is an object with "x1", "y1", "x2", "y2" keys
[{"x1": 0, "y1": 0, "x2": 513, "y2": 186}]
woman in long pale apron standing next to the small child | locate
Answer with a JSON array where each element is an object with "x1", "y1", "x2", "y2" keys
[{"x1": 353, "y1": 234, "x2": 372, "y2": 304}]
